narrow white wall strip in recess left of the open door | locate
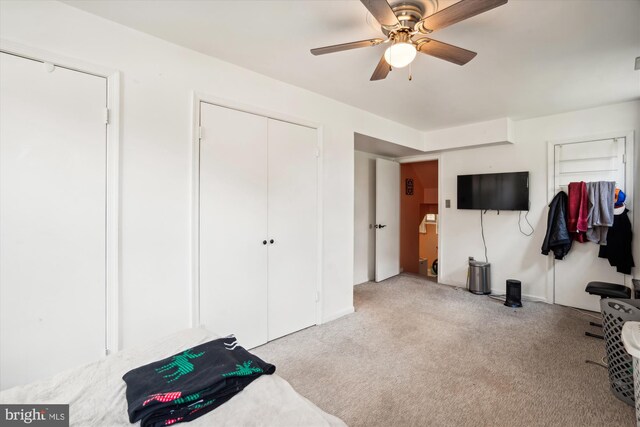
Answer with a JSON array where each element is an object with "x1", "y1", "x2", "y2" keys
[{"x1": 353, "y1": 151, "x2": 376, "y2": 285}]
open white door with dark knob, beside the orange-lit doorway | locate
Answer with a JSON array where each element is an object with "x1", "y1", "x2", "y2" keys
[{"x1": 375, "y1": 159, "x2": 400, "y2": 282}]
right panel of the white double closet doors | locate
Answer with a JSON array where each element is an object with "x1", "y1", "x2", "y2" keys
[{"x1": 268, "y1": 119, "x2": 318, "y2": 340}]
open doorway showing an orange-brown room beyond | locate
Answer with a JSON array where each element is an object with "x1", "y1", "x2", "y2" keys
[{"x1": 400, "y1": 160, "x2": 439, "y2": 282}]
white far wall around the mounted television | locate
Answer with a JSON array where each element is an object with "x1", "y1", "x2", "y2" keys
[{"x1": 439, "y1": 101, "x2": 640, "y2": 299}]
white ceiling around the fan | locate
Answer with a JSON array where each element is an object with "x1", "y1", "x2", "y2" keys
[{"x1": 66, "y1": 0, "x2": 640, "y2": 130}]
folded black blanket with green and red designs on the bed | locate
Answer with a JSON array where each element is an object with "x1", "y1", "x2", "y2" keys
[{"x1": 122, "y1": 336, "x2": 276, "y2": 426}]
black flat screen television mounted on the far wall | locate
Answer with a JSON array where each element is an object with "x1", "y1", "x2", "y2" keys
[{"x1": 458, "y1": 172, "x2": 529, "y2": 211}]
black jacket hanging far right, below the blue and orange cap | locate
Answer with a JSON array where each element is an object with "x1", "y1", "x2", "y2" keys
[{"x1": 598, "y1": 209, "x2": 634, "y2": 274}]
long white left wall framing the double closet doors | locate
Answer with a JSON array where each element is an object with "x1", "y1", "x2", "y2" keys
[{"x1": 0, "y1": 1, "x2": 423, "y2": 347}]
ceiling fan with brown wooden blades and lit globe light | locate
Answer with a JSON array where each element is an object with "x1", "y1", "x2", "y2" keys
[{"x1": 311, "y1": 0, "x2": 508, "y2": 80}]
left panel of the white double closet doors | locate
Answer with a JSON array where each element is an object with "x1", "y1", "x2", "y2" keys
[{"x1": 200, "y1": 103, "x2": 268, "y2": 348}]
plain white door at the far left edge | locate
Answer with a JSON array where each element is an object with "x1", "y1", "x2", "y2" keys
[{"x1": 0, "y1": 53, "x2": 107, "y2": 389}]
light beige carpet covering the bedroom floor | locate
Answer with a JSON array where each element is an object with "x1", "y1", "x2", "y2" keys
[{"x1": 254, "y1": 275, "x2": 635, "y2": 426}]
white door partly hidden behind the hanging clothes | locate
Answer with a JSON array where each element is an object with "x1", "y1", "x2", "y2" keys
[{"x1": 554, "y1": 138, "x2": 628, "y2": 311}]
